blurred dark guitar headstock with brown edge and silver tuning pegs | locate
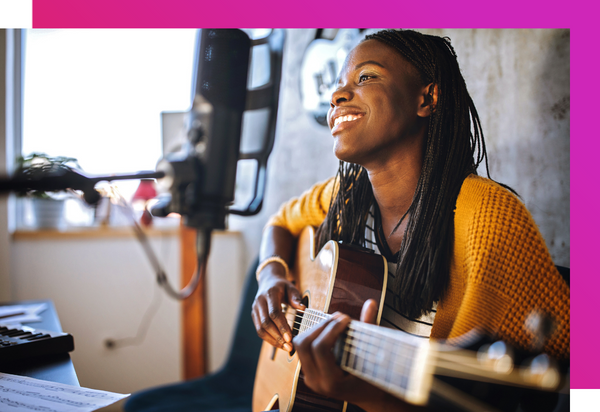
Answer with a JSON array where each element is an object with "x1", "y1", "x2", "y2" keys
[{"x1": 430, "y1": 330, "x2": 569, "y2": 412}]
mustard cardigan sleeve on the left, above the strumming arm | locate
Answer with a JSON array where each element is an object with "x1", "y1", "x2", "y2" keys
[{"x1": 267, "y1": 178, "x2": 336, "y2": 236}]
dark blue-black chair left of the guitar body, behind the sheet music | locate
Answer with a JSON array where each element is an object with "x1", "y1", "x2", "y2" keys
[{"x1": 124, "y1": 262, "x2": 262, "y2": 412}]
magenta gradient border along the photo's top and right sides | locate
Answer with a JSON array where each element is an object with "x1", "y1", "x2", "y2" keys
[{"x1": 33, "y1": 0, "x2": 600, "y2": 389}]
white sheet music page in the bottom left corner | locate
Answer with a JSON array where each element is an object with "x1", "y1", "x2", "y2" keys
[{"x1": 0, "y1": 372, "x2": 129, "y2": 412}]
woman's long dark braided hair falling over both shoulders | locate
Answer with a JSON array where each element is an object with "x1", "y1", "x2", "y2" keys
[{"x1": 318, "y1": 30, "x2": 489, "y2": 318}]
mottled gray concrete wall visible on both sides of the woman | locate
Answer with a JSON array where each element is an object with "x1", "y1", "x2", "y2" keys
[{"x1": 230, "y1": 29, "x2": 570, "y2": 266}]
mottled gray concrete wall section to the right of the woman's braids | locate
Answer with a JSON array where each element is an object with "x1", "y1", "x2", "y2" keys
[{"x1": 420, "y1": 30, "x2": 570, "y2": 267}]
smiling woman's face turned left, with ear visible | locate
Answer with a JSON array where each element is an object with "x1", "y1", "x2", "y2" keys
[{"x1": 328, "y1": 40, "x2": 429, "y2": 168}]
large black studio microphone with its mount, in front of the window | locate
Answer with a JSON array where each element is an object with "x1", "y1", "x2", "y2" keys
[{"x1": 151, "y1": 29, "x2": 284, "y2": 230}]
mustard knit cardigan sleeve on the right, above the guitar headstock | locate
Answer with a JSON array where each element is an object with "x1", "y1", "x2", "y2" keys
[{"x1": 450, "y1": 175, "x2": 570, "y2": 359}]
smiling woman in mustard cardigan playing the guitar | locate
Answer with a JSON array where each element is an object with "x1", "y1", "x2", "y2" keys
[{"x1": 252, "y1": 30, "x2": 569, "y2": 411}]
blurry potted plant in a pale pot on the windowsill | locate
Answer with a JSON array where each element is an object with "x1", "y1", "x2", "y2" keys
[{"x1": 14, "y1": 153, "x2": 80, "y2": 228}]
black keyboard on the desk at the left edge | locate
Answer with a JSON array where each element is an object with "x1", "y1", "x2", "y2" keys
[{"x1": 0, "y1": 325, "x2": 75, "y2": 363}]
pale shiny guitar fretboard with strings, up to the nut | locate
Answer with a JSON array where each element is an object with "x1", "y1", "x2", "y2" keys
[{"x1": 299, "y1": 309, "x2": 434, "y2": 404}]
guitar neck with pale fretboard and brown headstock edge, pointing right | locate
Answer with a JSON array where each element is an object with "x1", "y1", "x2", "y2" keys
[{"x1": 298, "y1": 309, "x2": 562, "y2": 405}]
